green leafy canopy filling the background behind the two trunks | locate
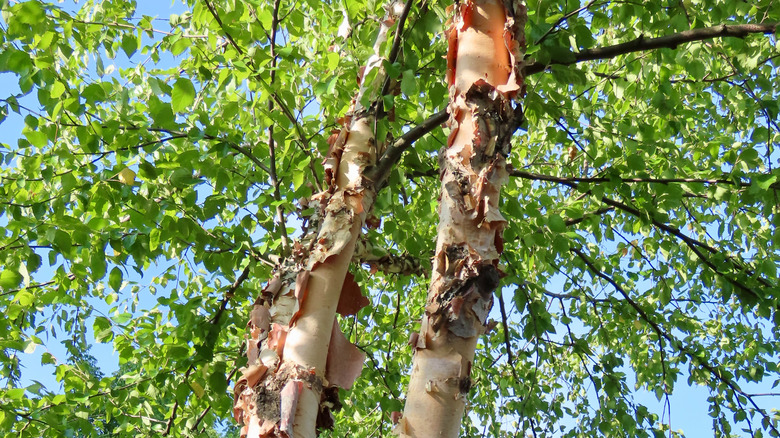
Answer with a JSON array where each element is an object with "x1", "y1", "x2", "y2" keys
[{"x1": 0, "y1": 0, "x2": 780, "y2": 437}]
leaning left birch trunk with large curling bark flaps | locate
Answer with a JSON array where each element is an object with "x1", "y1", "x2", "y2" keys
[{"x1": 234, "y1": 3, "x2": 402, "y2": 438}]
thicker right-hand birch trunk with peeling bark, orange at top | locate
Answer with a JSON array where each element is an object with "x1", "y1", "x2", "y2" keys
[{"x1": 395, "y1": 0, "x2": 526, "y2": 437}]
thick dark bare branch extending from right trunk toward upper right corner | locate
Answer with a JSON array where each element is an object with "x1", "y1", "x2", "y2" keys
[{"x1": 525, "y1": 23, "x2": 778, "y2": 76}]
